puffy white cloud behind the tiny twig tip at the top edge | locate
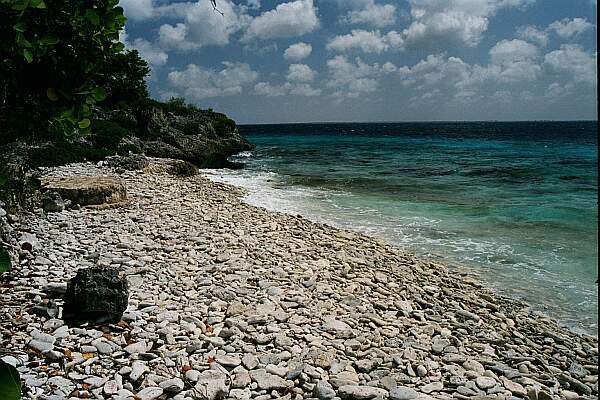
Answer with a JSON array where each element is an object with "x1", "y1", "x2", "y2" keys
[{"x1": 157, "y1": 0, "x2": 250, "y2": 51}]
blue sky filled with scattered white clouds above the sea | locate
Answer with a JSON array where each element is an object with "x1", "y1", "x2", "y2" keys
[{"x1": 120, "y1": 0, "x2": 597, "y2": 123}]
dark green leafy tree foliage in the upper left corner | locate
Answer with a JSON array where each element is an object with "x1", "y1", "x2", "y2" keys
[{"x1": 0, "y1": 0, "x2": 149, "y2": 139}]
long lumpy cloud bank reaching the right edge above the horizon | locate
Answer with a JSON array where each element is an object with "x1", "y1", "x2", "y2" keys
[{"x1": 397, "y1": 35, "x2": 597, "y2": 106}]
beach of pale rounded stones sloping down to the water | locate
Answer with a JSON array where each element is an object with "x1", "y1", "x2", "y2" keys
[{"x1": 0, "y1": 159, "x2": 598, "y2": 400}]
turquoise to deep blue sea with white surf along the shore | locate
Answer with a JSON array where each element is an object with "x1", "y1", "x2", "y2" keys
[{"x1": 205, "y1": 122, "x2": 598, "y2": 335}]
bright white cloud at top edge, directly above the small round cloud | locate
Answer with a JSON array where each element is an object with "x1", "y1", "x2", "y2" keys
[{"x1": 242, "y1": 0, "x2": 319, "y2": 42}]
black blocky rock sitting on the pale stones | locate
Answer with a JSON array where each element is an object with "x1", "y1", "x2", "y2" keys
[{"x1": 63, "y1": 267, "x2": 129, "y2": 325}]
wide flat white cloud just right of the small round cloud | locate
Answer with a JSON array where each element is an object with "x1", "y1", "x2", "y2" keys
[{"x1": 327, "y1": 29, "x2": 403, "y2": 54}]
